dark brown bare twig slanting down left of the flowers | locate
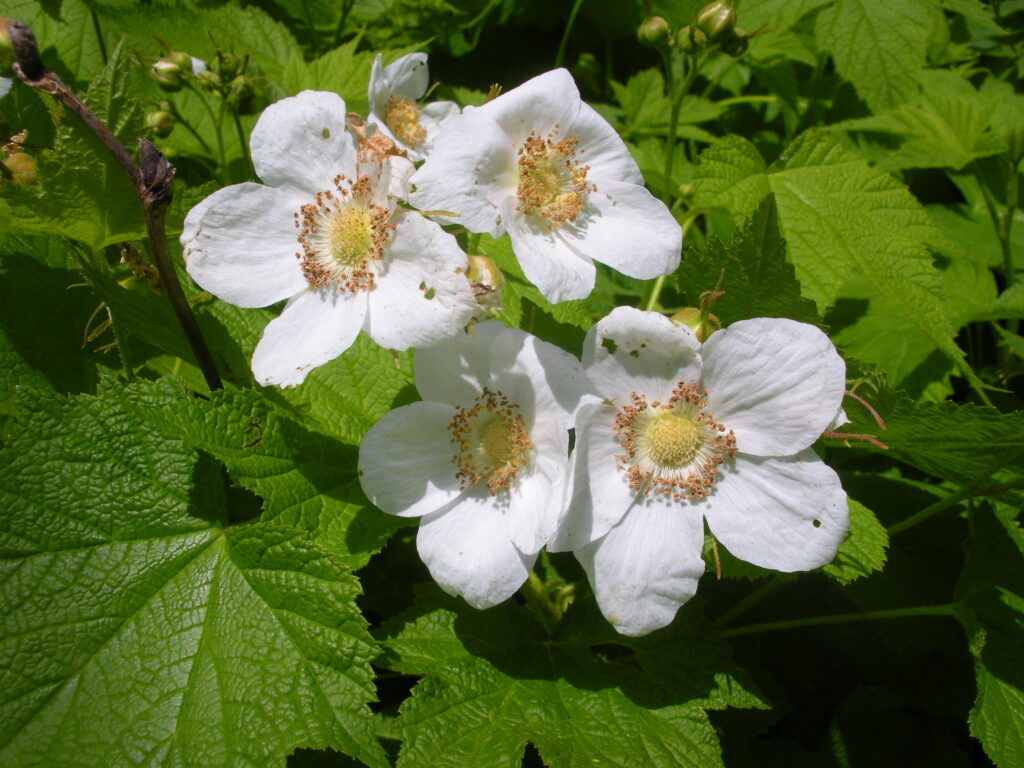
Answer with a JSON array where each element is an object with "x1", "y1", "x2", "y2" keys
[{"x1": 7, "y1": 22, "x2": 223, "y2": 390}]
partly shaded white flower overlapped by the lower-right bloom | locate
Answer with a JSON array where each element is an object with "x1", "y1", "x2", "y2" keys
[{"x1": 359, "y1": 322, "x2": 586, "y2": 608}]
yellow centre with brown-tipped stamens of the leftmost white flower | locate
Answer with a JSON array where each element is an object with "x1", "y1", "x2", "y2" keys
[{"x1": 294, "y1": 175, "x2": 394, "y2": 293}]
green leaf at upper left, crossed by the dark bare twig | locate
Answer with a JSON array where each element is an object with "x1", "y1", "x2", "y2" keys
[{"x1": 0, "y1": 39, "x2": 145, "y2": 250}]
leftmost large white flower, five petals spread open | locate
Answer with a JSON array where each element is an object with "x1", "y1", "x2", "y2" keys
[{"x1": 181, "y1": 91, "x2": 476, "y2": 386}]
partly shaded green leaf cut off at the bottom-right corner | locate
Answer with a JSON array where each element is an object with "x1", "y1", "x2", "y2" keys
[{"x1": 956, "y1": 505, "x2": 1024, "y2": 768}]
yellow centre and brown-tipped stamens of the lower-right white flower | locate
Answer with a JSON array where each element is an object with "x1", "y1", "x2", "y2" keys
[{"x1": 614, "y1": 382, "x2": 736, "y2": 500}]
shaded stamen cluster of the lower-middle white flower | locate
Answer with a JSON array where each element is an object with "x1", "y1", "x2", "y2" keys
[{"x1": 449, "y1": 388, "x2": 534, "y2": 495}]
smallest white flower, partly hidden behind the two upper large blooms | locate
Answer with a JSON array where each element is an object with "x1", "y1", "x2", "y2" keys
[{"x1": 368, "y1": 53, "x2": 459, "y2": 160}]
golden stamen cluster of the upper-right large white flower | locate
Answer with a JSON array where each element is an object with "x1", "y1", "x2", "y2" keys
[{"x1": 516, "y1": 125, "x2": 596, "y2": 227}]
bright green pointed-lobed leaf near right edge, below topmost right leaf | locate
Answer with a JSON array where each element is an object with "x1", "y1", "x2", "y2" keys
[{"x1": 831, "y1": 72, "x2": 1007, "y2": 170}]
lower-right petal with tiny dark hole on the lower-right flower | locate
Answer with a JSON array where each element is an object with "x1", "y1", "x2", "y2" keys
[{"x1": 697, "y1": 449, "x2": 849, "y2": 572}]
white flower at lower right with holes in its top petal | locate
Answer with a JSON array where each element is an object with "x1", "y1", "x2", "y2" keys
[{"x1": 549, "y1": 307, "x2": 848, "y2": 635}]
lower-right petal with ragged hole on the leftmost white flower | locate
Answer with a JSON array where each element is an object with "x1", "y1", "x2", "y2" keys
[{"x1": 367, "y1": 211, "x2": 478, "y2": 349}]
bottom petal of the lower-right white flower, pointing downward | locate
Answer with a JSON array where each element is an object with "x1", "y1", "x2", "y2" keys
[{"x1": 575, "y1": 497, "x2": 705, "y2": 636}]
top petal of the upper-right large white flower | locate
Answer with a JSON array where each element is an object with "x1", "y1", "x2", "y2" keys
[{"x1": 473, "y1": 70, "x2": 583, "y2": 146}]
